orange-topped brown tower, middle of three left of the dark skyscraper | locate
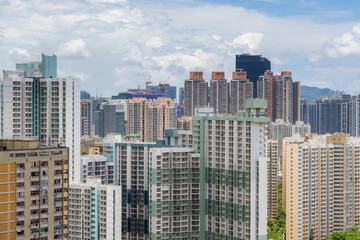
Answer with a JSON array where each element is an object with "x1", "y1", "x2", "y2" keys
[{"x1": 210, "y1": 72, "x2": 230, "y2": 114}]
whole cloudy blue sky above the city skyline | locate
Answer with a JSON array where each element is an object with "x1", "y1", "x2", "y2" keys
[{"x1": 0, "y1": 0, "x2": 360, "y2": 97}]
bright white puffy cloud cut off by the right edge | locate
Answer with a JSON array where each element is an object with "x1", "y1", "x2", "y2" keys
[{"x1": 325, "y1": 24, "x2": 360, "y2": 58}]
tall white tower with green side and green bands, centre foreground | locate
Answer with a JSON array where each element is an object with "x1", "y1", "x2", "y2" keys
[{"x1": 193, "y1": 100, "x2": 269, "y2": 239}]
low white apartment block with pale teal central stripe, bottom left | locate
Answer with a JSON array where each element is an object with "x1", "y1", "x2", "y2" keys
[{"x1": 69, "y1": 179, "x2": 121, "y2": 240}]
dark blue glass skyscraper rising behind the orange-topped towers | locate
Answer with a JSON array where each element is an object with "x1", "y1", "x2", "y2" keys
[{"x1": 235, "y1": 54, "x2": 271, "y2": 98}]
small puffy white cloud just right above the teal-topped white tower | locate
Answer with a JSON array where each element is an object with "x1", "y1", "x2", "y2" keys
[{"x1": 56, "y1": 38, "x2": 92, "y2": 58}]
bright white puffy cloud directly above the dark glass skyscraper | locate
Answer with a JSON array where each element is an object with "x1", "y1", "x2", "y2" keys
[{"x1": 232, "y1": 32, "x2": 264, "y2": 53}]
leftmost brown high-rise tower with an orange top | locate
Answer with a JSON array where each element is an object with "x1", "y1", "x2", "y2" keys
[{"x1": 184, "y1": 72, "x2": 209, "y2": 116}]
